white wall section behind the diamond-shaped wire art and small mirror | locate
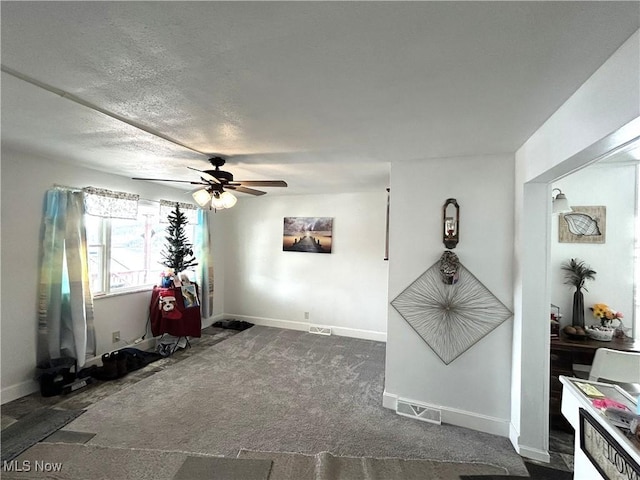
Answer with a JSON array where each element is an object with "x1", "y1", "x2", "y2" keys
[{"x1": 385, "y1": 156, "x2": 514, "y2": 436}]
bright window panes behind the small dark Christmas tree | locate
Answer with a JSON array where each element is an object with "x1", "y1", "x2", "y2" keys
[{"x1": 86, "y1": 201, "x2": 196, "y2": 295}]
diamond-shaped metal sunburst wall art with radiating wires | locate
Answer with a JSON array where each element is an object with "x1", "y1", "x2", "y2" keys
[{"x1": 391, "y1": 251, "x2": 513, "y2": 365}]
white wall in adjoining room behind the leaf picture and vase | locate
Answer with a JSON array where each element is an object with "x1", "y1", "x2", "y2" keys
[{"x1": 550, "y1": 163, "x2": 636, "y2": 327}]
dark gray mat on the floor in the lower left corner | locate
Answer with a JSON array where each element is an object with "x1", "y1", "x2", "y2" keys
[{"x1": 1, "y1": 408, "x2": 84, "y2": 463}]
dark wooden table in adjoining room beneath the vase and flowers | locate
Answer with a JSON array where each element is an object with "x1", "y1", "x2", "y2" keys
[{"x1": 549, "y1": 333, "x2": 640, "y2": 430}]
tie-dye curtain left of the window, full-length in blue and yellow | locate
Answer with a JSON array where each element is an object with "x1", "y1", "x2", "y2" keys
[{"x1": 38, "y1": 187, "x2": 96, "y2": 366}]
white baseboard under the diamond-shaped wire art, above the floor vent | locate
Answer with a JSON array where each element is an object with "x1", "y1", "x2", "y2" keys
[{"x1": 382, "y1": 390, "x2": 510, "y2": 437}]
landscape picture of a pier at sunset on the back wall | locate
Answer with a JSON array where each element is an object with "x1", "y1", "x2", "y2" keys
[{"x1": 282, "y1": 217, "x2": 333, "y2": 253}]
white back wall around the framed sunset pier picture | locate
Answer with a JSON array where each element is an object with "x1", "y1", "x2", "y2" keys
[{"x1": 220, "y1": 190, "x2": 388, "y2": 340}]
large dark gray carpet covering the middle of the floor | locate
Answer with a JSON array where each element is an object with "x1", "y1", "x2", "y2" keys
[{"x1": 62, "y1": 326, "x2": 526, "y2": 475}]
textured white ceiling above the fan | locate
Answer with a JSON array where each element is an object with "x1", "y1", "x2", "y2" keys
[{"x1": 0, "y1": 1, "x2": 640, "y2": 193}]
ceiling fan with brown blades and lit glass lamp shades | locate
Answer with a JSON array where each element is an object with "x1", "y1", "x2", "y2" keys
[{"x1": 132, "y1": 157, "x2": 287, "y2": 209}]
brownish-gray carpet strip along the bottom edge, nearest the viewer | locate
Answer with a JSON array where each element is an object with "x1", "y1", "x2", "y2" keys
[{"x1": 2, "y1": 443, "x2": 507, "y2": 480}]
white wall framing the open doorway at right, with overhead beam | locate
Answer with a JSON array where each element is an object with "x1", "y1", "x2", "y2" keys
[{"x1": 509, "y1": 32, "x2": 640, "y2": 460}]
